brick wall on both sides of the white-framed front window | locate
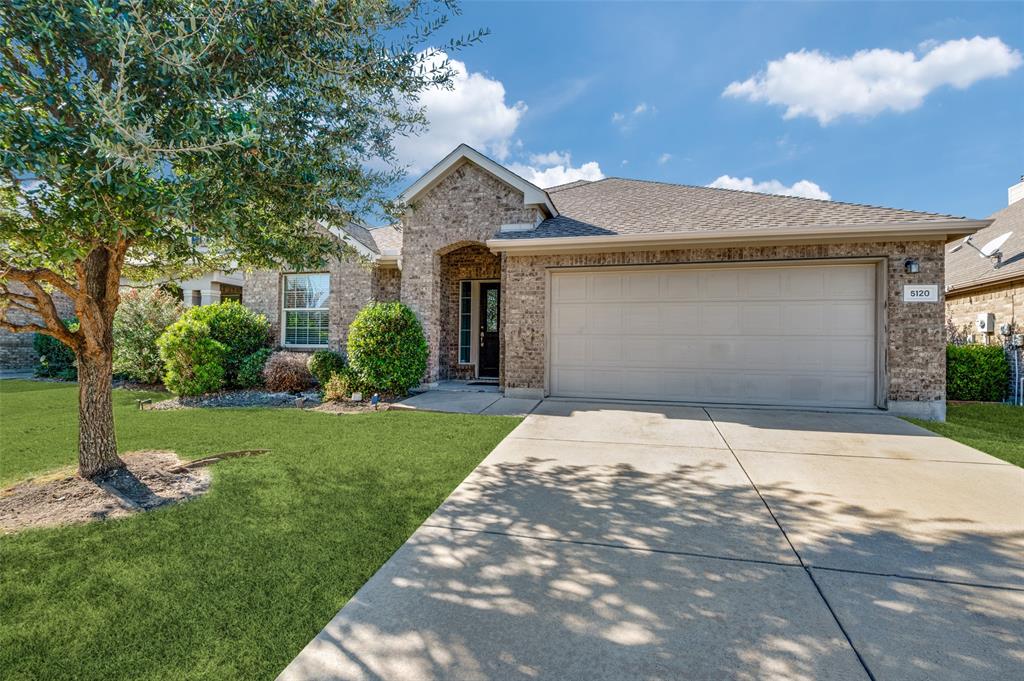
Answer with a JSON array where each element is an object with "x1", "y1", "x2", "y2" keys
[{"x1": 243, "y1": 253, "x2": 374, "y2": 350}]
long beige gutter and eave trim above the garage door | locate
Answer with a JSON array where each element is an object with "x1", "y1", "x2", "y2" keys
[{"x1": 486, "y1": 219, "x2": 992, "y2": 255}]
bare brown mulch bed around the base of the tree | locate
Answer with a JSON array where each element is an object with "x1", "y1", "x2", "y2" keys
[{"x1": 0, "y1": 452, "x2": 210, "y2": 533}]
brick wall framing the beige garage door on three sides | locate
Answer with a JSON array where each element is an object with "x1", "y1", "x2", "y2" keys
[{"x1": 502, "y1": 241, "x2": 946, "y2": 402}]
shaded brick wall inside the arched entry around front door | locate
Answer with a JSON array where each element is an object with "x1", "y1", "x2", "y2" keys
[{"x1": 438, "y1": 244, "x2": 502, "y2": 379}]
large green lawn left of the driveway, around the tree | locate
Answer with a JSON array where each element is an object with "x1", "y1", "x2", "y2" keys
[{"x1": 0, "y1": 381, "x2": 519, "y2": 680}]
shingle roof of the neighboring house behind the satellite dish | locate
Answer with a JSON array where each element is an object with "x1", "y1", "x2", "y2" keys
[{"x1": 946, "y1": 200, "x2": 1024, "y2": 291}]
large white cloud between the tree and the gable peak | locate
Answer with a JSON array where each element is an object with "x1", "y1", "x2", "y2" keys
[{"x1": 395, "y1": 52, "x2": 526, "y2": 173}]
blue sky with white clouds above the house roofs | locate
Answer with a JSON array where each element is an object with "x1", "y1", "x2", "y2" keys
[{"x1": 387, "y1": 2, "x2": 1024, "y2": 217}]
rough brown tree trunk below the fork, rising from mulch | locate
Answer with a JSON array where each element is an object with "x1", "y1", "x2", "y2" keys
[{"x1": 78, "y1": 349, "x2": 125, "y2": 478}]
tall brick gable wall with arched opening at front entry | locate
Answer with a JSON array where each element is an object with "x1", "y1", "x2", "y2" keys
[{"x1": 401, "y1": 162, "x2": 540, "y2": 381}]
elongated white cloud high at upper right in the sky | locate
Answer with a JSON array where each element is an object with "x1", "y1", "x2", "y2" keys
[{"x1": 722, "y1": 36, "x2": 1024, "y2": 125}]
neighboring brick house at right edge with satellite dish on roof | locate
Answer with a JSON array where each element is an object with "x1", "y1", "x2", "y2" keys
[{"x1": 946, "y1": 177, "x2": 1024, "y2": 343}]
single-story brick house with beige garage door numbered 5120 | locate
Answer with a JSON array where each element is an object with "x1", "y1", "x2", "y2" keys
[{"x1": 246, "y1": 145, "x2": 988, "y2": 419}]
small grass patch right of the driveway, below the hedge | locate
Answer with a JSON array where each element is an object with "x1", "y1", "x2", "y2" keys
[{"x1": 907, "y1": 405, "x2": 1024, "y2": 468}]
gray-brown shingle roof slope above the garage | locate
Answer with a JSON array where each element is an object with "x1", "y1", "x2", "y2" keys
[{"x1": 501, "y1": 177, "x2": 964, "y2": 239}]
